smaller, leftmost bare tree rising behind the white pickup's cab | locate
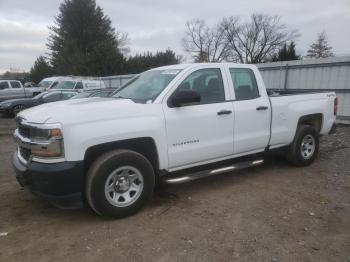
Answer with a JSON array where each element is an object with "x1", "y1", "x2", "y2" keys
[{"x1": 182, "y1": 19, "x2": 228, "y2": 62}]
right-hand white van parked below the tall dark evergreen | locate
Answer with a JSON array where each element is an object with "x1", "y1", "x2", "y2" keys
[{"x1": 51, "y1": 78, "x2": 106, "y2": 90}]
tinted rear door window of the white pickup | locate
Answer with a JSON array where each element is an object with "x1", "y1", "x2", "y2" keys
[{"x1": 230, "y1": 68, "x2": 259, "y2": 100}]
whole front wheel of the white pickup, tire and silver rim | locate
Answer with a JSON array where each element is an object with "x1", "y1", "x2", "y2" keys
[{"x1": 85, "y1": 150, "x2": 155, "y2": 218}]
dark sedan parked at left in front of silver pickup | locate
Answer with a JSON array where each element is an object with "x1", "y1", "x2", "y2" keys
[{"x1": 0, "y1": 90, "x2": 77, "y2": 116}]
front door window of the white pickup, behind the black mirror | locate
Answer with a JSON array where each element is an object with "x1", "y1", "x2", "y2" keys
[{"x1": 175, "y1": 68, "x2": 225, "y2": 104}]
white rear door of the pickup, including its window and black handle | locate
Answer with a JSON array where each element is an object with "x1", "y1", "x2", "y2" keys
[{"x1": 227, "y1": 66, "x2": 271, "y2": 154}]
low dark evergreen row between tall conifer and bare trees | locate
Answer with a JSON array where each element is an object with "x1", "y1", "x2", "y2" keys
[{"x1": 125, "y1": 49, "x2": 180, "y2": 74}]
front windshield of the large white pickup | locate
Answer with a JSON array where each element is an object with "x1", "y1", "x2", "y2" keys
[{"x1": 113, "y1": 69, "x2": 181, "y2": 103}]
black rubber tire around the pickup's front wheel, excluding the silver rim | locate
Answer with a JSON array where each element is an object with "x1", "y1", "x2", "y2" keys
[{"x1": 85, "y1": 150, "x2": 155, "y2": 218}]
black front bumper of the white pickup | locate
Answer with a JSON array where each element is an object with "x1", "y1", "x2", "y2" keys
[{"x1": 12, "y1": 152, "x2": 84, "y2": 208}]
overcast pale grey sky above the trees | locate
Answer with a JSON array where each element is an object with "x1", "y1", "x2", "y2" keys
[{"x1": 0, "y1": 0, "x2": 350, "y2": 73}]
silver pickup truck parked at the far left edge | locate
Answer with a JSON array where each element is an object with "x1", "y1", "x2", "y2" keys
[{"x1": 0, "y1": 80, "x2": 43, "y2": 102}]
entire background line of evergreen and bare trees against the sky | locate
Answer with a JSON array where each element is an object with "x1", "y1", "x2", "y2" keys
[{"x1": 25, "y1": 0, "x2": 333, "y2": 82}]
